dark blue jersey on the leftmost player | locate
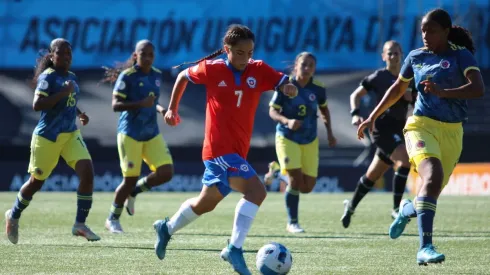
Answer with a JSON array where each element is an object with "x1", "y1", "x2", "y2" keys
[{"x1": 34, "y1": 68, "x2": 80, "y2": 142}]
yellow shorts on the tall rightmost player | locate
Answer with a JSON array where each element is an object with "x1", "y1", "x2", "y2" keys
[{"x1": 403, "y1": 116, "x2": 463, "y2": 187}]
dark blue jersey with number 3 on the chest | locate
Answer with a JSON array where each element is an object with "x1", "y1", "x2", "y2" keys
[{"x1": 269, "y1": 78, "x2": 327, "y2": 144}]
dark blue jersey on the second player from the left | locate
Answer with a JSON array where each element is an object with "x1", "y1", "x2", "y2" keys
[{"x1": 113, "y1": 65, "x2": 162, "y2": 141}]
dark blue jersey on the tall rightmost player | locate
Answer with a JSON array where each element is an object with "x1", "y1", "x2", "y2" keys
[{"x1": 400, "y1": 44, "x2": 479, "y2": 123}]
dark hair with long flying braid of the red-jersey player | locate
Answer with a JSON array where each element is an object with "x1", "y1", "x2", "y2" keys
[{"x1": 173, "y1": 24, "x2": 255, "y2": 69}]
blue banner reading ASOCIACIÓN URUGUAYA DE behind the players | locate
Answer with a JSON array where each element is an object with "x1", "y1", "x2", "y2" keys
[{"x1": 0, "y1": 0, "x2": 490, "y2": 70}]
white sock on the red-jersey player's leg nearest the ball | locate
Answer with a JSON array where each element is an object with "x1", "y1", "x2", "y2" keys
[{"x1": 230, "y1": 199, "x2": 259, "y2": 248}]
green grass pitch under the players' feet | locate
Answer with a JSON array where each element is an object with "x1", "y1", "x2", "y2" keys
[{"x1": 0, "y1": 192, "x2": 490, "y2": 275}]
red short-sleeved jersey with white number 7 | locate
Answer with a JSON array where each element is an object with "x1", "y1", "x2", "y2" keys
[{"x1": 186, "y1": 59, "x2": 287, "y2": 160}]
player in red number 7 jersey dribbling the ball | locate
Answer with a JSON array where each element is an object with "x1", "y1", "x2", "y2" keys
[{"x1": 154, "y1": 25, "x2": 298, "y2": 274}]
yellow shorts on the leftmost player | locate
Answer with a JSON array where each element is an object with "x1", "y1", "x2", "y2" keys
[{"x1": 28, "y1": 130, "x2": 91, "y2": 180}]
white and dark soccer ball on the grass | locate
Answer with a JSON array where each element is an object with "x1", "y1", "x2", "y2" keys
[{"x1": 256, "y1": 242, "x2": 293, "y2": 275}]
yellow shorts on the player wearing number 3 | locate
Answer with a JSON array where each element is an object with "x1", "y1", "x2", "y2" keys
[{"x1": 276, "y1": 135, "x2": 319, "y2": 178}]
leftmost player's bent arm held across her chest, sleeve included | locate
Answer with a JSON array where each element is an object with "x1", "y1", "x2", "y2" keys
[{"x1": 32, "y1": 74, "x2": 75, "y2": 112}]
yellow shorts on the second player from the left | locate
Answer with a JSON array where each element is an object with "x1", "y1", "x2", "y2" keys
[{"x1": 117, "y1": 133, "x2": 173, "y2": 177}]
